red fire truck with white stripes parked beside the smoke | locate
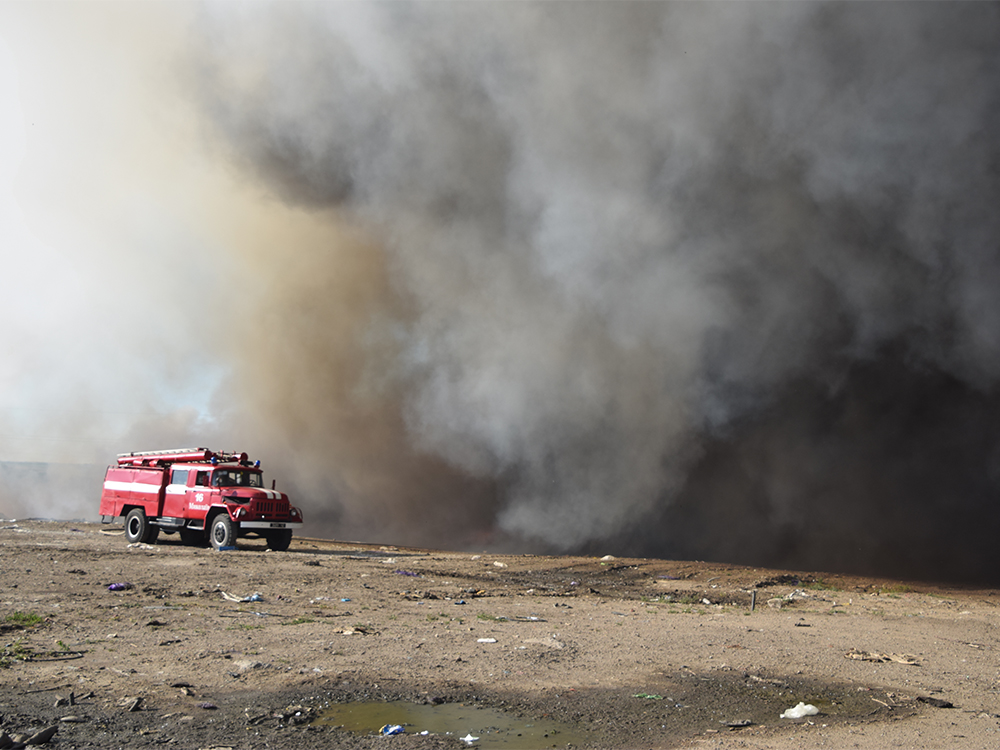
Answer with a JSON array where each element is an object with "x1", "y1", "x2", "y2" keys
[{"x1": 101, "y1": 448, "x2": 302, "y2": 550}]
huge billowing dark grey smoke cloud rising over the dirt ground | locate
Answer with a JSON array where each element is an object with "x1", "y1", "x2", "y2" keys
[{"x1": 192, "y1": 3, "x2": 1000, "y2": 579}]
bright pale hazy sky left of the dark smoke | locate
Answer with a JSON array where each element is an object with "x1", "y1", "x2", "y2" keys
[{"x1": 0, "y1": 2, "x2": 324, "y2": 463}]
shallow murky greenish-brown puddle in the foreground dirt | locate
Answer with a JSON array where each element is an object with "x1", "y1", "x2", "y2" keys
[{"x1": 316, "y1": 701, "x2": 586, "y2": 750}]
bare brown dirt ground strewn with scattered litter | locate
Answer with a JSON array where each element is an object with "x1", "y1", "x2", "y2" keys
[{"x1": 0, "y1": 521, "x2": 1000, "y2": 748}]
